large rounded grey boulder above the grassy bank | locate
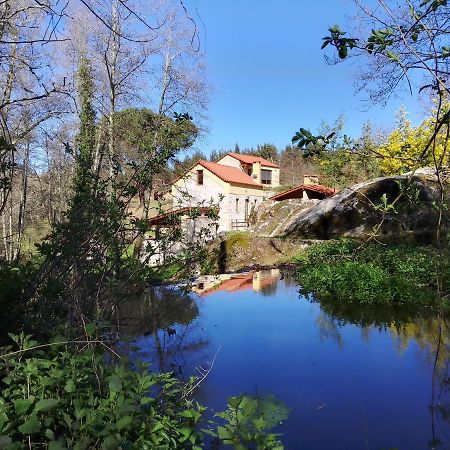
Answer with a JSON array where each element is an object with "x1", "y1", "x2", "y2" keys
[{"x1": 281, "y1": 172, "x2": 450, "y2": 242}]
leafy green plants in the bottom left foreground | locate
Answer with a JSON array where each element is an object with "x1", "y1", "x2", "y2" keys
[{"x1": 0, "y1": 332, "x2": 287, "y2": 450}]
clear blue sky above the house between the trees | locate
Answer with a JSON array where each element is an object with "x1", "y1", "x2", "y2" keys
[{"x1": 186, "y1": 0, "x2": 423, "y2": 154}]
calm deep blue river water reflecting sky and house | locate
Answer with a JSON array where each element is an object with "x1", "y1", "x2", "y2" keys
[{"x1": 124, "y1": 270, "x2": 450, "y2": 450}]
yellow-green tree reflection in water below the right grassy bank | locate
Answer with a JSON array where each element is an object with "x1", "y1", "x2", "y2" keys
[{"x1": 310, "y1": 297, "x2": 450, "y2": 449}]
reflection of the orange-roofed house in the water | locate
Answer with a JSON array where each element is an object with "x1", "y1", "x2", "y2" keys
[{"x1": 192, "y1": 269, "x2": 280, "y2": 297}]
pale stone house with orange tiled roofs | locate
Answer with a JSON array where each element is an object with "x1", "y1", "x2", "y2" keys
[{"x1": 172, "y1": 153, "x2": 280, "y2": 232}]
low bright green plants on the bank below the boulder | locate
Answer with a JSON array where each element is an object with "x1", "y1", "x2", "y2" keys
[{"x1": 295, "y1": 239, "x2": 450, "y2": 305}]
